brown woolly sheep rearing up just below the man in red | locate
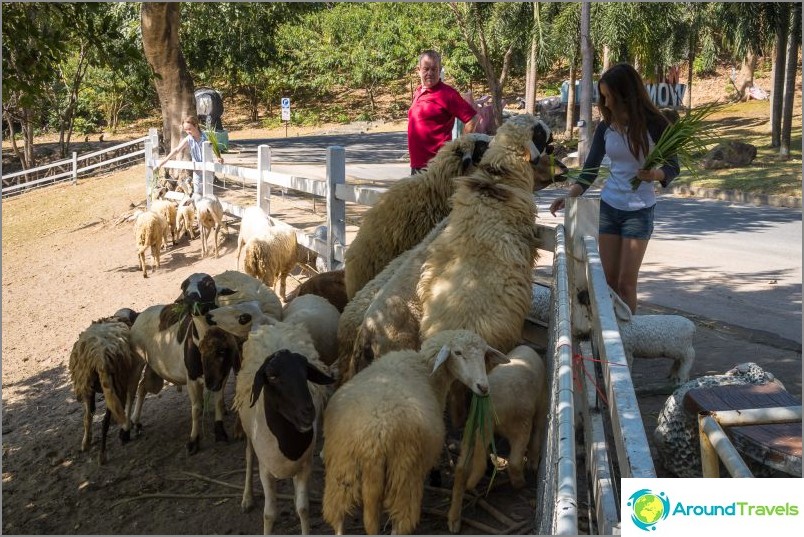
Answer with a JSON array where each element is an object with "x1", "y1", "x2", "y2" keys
[{"x1": 344, "y1": 134, "x2": 490, "y2": 299}]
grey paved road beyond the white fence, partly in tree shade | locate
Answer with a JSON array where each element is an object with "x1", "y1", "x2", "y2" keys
[{"x1": 229, "y1": 132, "x2": 802, "y2": 348}]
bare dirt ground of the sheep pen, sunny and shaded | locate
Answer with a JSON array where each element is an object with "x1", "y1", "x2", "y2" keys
[{"x1": 2, "y1": 166, "x2": 548, "y2": 535}]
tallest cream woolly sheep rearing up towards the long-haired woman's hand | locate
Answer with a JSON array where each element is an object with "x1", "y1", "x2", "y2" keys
[{"x1": 416, "y1": 114, "x2": 552, "y2": 352}]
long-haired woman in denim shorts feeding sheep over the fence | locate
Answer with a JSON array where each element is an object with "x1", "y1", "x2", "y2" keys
[{"x1": 550, "y1": 63, "x2": 680, "y2": 312}]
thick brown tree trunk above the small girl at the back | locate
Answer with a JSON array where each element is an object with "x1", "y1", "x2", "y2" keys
[{"x1": 140, "y1": 2, "x2": 197, "y2": 151}]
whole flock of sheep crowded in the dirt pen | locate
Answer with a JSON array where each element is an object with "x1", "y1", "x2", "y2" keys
[{"x1": 69, "y1": 114, "x2": 780, "y2": 534}]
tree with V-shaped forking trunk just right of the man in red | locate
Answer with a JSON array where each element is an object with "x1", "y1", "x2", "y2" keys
[{"x1": 449, "y1": 2, "x2": 532, "y2": 130}]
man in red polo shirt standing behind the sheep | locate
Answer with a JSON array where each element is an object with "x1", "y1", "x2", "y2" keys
[{"x1": 408, "y1": 50, "x2": 477, "y2": 175}]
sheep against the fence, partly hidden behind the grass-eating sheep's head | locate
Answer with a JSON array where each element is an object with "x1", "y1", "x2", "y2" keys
[{"x1": 447, "y1": 345, "x2": 549, "y2": 533}]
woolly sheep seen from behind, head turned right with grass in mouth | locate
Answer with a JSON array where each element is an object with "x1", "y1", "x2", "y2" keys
[{"x1": 323, "y1": 330, "x2": 508, "y2": 535}]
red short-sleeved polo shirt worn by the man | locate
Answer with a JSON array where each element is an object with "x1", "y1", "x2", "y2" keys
[{"x1": 408, "y1": 81, "x2": 477, "y2": 168}]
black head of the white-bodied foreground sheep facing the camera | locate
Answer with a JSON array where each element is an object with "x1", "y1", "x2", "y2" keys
[{"x1": 251, "y1": 349, "x2": 335, "y2": 461}]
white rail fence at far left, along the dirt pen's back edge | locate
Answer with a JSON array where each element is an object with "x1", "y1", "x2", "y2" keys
[{"x1": 2, "y1": 135, "x2": 149, "y2": 197}]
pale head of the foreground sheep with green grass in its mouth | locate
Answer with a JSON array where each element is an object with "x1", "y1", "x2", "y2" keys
[{"x1": 422, "y1": 330, "x2": 509, "y2": 396}]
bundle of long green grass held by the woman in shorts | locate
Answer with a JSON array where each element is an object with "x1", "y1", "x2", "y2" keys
[{"x1": 631, "y1": 102, "x2": 718, "y2": 190}]
